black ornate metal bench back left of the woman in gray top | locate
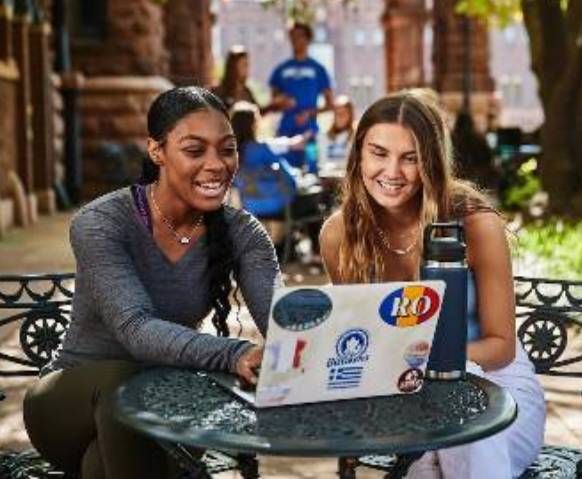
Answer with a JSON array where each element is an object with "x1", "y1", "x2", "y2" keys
[{"x1": 0, "y1": 273, "x2": 75, "y2": 377}]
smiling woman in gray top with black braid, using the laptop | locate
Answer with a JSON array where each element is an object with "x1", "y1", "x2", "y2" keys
[{"x1": 24, "y1": 87, "x2": 281, "y2": 479}]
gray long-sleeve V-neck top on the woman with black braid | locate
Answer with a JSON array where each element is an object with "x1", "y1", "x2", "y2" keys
[{"x1": 43, "y1": 188, "x2": 281, "y2": 374}]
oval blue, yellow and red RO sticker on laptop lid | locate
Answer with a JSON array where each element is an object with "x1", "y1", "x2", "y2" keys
[{"x1": 379, "y1": 285, "x2": 441, "y2": 328}]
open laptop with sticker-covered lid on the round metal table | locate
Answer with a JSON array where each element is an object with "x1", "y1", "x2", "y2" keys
[{"x1": 210, "y1": 280, "x2": 445, "y2": 408}]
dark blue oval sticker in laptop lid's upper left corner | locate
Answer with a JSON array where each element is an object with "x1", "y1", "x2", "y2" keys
[{"x1": 273, "y1": 288, "x2": 332, "y2": 331}]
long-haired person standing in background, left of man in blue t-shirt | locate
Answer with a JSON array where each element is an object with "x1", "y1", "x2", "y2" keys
[{"x1": 212, "y1": 45, "x2": 257, "y2": 110}]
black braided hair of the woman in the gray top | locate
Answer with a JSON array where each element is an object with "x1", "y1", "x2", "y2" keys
[{"x1": 139, "y1": 86, "x2": 238, "y2": 336}]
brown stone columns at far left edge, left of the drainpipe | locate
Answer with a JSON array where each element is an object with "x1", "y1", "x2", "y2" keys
[{"x1": 0, "y1": 0, "x2": 58, "y2": 235}]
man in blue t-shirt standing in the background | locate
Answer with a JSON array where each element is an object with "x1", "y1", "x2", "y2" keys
[{"x1": 269, "y1": 23, "x2": 333, "y2": 166}]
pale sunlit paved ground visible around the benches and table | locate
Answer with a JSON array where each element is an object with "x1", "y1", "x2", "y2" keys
[{"x1": 0, "y1": 213, "x2": 582, "y2": 479}]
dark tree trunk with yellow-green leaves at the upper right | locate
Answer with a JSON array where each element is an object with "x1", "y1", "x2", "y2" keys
[{"x1": 457, "y1": 0, "x2": 582, "y2": 216}]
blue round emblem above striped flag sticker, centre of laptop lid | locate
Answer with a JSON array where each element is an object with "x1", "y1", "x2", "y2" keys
[{"x1": 327, "y1": 328, "x2": 369, "y2": 390}]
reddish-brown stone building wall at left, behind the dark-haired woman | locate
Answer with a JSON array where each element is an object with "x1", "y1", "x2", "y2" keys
[{"x1": 0, "y1": 0, "x2": 212, "y2": 237}]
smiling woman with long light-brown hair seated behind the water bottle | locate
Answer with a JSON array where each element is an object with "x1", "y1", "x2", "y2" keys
[{"x1": 320, "y1": 90, "x2": 546, "y2": 479}]
